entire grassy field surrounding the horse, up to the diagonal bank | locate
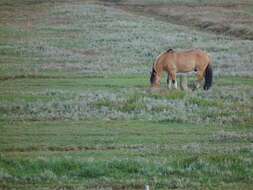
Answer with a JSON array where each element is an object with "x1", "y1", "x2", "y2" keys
[{"x1": 0, "y1": 0, "x2": 253, "y2": 189}]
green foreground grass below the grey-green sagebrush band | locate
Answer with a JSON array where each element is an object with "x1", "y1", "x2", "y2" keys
[{"x1": 0, "y1": 121, "x2": 253, "y2": 189}]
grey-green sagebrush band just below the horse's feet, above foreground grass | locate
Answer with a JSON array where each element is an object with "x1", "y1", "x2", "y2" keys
[{"x1": 0, "y1": 87, "x2": 253, "y2": 125}]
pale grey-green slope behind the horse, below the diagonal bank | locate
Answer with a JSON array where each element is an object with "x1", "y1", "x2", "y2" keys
[{"x1": 0, "y1": 1, "x2": 253, "y2": 77}]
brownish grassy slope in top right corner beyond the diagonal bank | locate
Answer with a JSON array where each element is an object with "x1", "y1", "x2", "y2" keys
[{"x1": 107, "y1": 0, "x2": 253, "y2": 40}]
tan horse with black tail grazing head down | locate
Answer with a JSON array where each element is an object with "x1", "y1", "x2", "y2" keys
[{"x1": 150, "y1": 49, "x2": 213, "y2": 90}]
